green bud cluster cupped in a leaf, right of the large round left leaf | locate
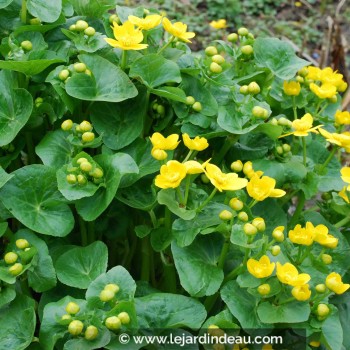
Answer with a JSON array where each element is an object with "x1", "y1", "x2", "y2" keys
[{"x1": 66, "y1": 157, "x2": 104, "y2": 186}]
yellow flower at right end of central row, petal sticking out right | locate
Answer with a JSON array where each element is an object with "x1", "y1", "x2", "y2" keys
[{"x1": 247, "y1": 174, "x2": 286, "y2": 201}]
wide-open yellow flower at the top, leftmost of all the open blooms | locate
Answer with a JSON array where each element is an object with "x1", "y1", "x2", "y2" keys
[{"x1": 105, "y1": 21, "x2": 148, "y2": 50}]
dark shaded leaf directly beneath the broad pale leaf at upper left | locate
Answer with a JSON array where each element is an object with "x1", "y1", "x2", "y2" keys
[{"x1": 91, "y1": 89, "x2": 148, "y2": 150}]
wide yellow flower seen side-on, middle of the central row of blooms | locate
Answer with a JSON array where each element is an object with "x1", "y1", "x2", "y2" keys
[{"x1": 205, "y1": 163, "x2": 248, "y2": 192}]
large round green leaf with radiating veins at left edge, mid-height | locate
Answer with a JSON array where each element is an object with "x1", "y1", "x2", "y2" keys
[{"x1": 0, "y1": 164, "x2": 74, "y2": 237}]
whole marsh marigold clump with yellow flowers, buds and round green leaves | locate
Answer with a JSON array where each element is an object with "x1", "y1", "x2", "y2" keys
[{"x1": 0, "y1": 0, "x2": 350, "y2": 350}]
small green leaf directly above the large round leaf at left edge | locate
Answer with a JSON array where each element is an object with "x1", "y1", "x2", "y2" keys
[{"x1": 35, "y1": 130, "x2": 74, "y2": 169}]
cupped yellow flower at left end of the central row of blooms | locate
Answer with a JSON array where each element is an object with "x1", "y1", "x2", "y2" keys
[{"x1": 155, "y1": 160, "x2": 187, "y2": 188}]
